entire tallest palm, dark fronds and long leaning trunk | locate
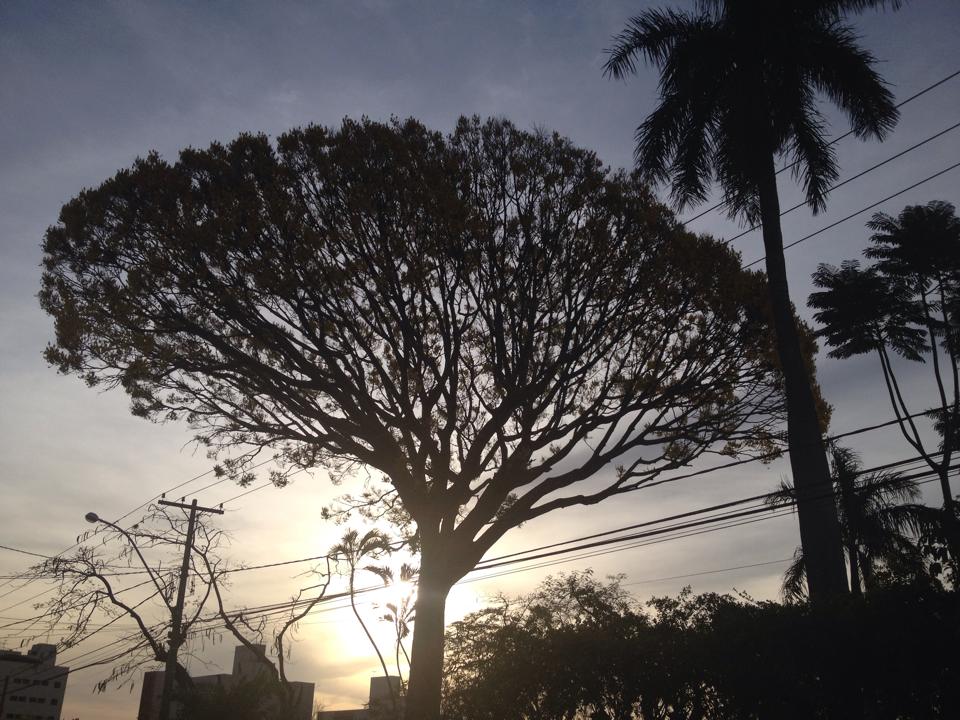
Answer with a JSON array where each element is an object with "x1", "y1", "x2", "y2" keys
[{"x1": 605, "y1": 0, "x2": 898, "y2": 599}]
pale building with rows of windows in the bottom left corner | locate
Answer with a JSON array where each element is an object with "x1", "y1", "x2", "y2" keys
[{"x1": 0, "y1": 644, "x2": 70, "y2": 720}]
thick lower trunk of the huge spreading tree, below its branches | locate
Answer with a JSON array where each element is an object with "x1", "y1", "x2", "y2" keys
[{"x1": 403, "y1": 564, "x2": 455, "y2": 720}]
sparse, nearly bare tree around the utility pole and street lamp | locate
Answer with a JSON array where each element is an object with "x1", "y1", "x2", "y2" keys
[{"x1": 31, "y1": 505, "x2": 318, "y2": 717}]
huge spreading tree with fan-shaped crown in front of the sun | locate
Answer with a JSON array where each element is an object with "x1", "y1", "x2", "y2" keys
[{"x1": 41, "y1": 119, "x2": 782, "y2": 720}]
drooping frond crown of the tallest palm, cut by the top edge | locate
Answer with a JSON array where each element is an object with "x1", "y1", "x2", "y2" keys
[{"x1": 605, "y1": 0, "x2": 898, "y2": 223}]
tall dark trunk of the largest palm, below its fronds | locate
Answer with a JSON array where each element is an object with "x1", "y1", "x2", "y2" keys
[{"x1": 758, "y1": 155, "x2": 848, "y2": 601}]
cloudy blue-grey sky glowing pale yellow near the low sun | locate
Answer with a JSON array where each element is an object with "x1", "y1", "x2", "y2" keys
[{"x1": 0, "y1": 0, "x2": 960, "y2": 720}]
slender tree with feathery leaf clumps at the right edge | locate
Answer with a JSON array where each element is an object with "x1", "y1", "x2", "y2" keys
[{"x1": 809, "y1": 201, "x2": 960, "y2": 561}]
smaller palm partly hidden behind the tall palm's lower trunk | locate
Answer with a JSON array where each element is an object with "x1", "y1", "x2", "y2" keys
[{"x1": 767, "y1": 447, "x2": 935, "y2": 601}]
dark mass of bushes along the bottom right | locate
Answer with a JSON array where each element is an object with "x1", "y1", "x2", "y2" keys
[{"x1": 444, "y1": 574, "x2": 960, "y2": 720}]
